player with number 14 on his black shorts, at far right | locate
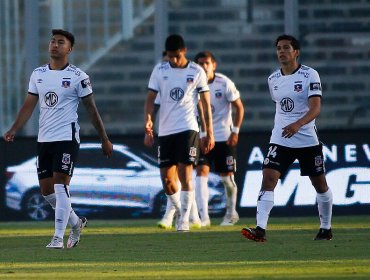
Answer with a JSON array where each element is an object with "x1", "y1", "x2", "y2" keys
[{"x1": 242, "y1": 35, "x2": 333, "y2": 242}]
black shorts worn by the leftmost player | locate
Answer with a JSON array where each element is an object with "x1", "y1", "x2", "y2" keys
[{"x1": 37, "y1": 140, "x2": 80, "y2": 180}]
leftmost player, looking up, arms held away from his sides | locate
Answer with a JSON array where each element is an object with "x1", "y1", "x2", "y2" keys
[{"x1": 4, "y1": 29, "x2": 113, "y2": 249}]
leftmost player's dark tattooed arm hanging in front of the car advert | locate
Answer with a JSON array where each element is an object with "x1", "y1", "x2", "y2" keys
[{"x1": 82, "y1": 94, "x2": 113, "y2": 157}]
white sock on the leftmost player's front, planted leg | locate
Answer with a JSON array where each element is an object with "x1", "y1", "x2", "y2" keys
[{"x1": 54, "y1": 184, "x2": 72, "y2": 238}]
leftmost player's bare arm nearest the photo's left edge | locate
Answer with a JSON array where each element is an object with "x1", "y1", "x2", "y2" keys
[{"x1": 4, "y1": 93, "x2": 39, "y2": 142}]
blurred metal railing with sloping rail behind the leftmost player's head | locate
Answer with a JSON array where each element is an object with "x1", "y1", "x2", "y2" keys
[{"x1": 0, "y1": 0, "x2": 155, "y2": 135}]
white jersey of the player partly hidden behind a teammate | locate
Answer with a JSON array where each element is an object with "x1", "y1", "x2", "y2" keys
[{"x1": 209, "y1": 73, "x2": 240, "y2": 142}]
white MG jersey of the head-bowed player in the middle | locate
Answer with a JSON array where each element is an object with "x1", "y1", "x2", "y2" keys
[{"x1": 148, "y1": 61, "x2": 209, "y2": 136}]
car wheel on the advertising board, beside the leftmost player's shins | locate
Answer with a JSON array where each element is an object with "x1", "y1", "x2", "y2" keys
[{"x1": 22, "y1": 190, "x2": 52, "y2": 221}]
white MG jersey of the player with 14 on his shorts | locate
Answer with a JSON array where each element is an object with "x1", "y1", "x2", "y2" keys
[{"x1": 268, "y1": 65, "x2": 322, "y2": 148}]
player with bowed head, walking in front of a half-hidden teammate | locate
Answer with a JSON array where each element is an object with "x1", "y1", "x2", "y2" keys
[{"x1": 144, "y1": 34, "x2": 214, "y2": 231}]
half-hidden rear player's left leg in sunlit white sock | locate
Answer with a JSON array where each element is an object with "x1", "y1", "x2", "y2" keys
[{"x1": 195, "y1": 163, "x2": 211, "y2": 227}]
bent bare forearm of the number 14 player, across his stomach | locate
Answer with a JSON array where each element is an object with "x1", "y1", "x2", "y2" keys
[{"x1": 281, "y1": 96, "x2": 321, "y2": 138}]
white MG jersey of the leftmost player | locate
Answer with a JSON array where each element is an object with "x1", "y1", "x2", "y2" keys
[{"x1": 28, "y1": 64, "x2": 92, "y2": 142}]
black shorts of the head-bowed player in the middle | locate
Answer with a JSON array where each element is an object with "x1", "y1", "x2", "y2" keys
[{"x1": 158, "y1": 130, "x2": 199, "y2": 167}]
